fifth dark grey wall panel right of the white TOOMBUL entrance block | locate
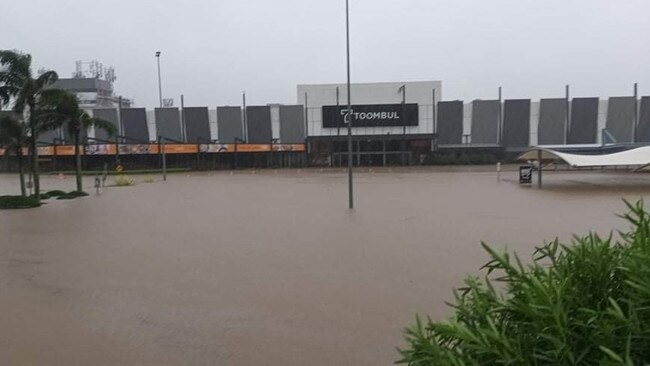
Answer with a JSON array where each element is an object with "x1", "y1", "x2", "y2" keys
[{"x1": 567, "y1": 98, "x2": 598, "y2": 144}]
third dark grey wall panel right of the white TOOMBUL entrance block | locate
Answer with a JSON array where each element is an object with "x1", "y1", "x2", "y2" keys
[{"x1": 502, "y1": 99, "x2": 530, "y2": 147}]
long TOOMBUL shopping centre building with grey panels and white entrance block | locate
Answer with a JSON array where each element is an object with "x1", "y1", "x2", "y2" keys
[{"x1": 1, "y1": 81, "x2": 650, "y2": 168}]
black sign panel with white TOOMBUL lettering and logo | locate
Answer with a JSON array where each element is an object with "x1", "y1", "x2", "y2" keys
[{"x1": 323, "y1": 103, "x2": 418, "y2": 128}]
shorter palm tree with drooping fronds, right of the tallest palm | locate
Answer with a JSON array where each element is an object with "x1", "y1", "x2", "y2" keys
[{"x1": 37, "y1": 90, "x2": 116, "y2": 192}]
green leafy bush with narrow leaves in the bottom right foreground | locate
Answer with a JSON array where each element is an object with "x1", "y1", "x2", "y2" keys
[{"x1": 399, "y1": 202, "x2": 650, "y2": 366}]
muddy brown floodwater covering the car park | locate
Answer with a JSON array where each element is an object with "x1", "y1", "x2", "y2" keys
[{"x1": 0, "y1": 167, "x2": 650, "y2": 366}]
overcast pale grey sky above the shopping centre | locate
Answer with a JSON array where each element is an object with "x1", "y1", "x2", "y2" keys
[{"x1": 0, "y1": 0, "x2": 650, "y2": 107}]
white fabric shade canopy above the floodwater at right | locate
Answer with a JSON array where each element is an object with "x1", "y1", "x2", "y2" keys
[{"x1": 517, "y1": 146, "x2": 650, "y2": 168}]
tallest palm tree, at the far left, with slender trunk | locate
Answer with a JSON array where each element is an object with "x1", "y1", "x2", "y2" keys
[{"x1": 0, "y1": 50, "x2": 59, "y2": 199}]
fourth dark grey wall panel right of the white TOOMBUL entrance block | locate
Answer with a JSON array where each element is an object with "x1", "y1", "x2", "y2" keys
[{"x1": 537, "y1": 98, "x2": 567, "y2": 145}]
